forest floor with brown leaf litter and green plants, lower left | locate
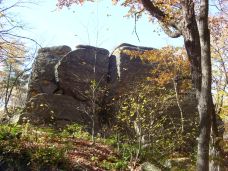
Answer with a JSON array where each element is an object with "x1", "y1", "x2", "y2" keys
[{"x1": 0, "y1": 126, "x2": 128, "y2": 171}]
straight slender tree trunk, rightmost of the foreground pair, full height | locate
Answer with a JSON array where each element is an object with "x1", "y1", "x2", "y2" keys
[{"x1": 197, "y1": 0, "x2": 213, "y2": 171}]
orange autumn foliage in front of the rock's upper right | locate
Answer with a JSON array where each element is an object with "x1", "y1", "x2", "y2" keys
[{"x1": 124, "y1": 46, "x2": 191, "y2": 89}]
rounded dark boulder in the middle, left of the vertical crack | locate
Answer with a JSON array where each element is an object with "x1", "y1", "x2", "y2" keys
[{"x1": 57, "y1": 45, "x2": 109, "y2": 101}]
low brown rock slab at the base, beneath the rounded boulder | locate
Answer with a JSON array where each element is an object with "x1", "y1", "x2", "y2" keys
[{"x1": 20, "y1": 94, "x2": 90, "y2": 127}]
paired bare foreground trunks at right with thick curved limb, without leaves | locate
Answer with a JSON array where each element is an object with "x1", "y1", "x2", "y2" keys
[{"x1": 142, "y1": 0, "x2": 219, "y2": 171}]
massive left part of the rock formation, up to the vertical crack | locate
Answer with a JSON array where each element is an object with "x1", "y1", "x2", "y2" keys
[{"x1": 20, "y1": 45, "x2": 109, "y2": 129}]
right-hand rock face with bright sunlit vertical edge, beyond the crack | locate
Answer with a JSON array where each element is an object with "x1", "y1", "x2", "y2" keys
[{"x1": 105, "y1": 43, "x2": 156, "y2": 107}]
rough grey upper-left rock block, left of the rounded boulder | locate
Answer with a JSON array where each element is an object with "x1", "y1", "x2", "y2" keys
[{"x1": 27, "y1": 46, "x2": 71, "y2": 100}]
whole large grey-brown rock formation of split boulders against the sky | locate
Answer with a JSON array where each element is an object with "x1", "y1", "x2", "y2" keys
[{"x1": 20, "y1": 44, "x2": 195, "y2": 129}]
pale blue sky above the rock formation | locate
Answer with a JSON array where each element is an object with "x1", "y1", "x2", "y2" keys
[{"x1": 3, "y1": 0, "x2": 183, "y2": 50}]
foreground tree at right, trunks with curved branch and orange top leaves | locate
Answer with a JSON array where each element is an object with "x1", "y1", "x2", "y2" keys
[{"x1": 57, "y1": 0, "x2": 224, "y2": 171}]
